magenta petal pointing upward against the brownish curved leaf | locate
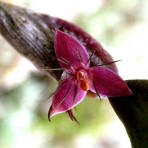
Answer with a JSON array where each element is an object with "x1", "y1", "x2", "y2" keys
[{"x1": 54, "y1": 30, "x2": 89, "y2": 70}]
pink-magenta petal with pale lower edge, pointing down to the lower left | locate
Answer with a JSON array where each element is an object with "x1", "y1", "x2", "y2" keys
[{"x1": 49, "y1": 78, "x2": 87, "y2": 118}]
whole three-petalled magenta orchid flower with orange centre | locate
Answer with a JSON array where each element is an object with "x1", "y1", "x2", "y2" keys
[{"x1": 48, "y1": 30, "x2": 132, "y2": 120}]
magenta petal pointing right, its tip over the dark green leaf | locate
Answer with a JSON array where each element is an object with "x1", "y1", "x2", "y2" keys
[{"x1": 90, "y1": 67, "x2": 132, "y2": 97}]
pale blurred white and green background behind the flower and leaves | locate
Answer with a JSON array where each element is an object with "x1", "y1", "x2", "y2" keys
[{"x1": 0, "y1": 0, "x2": 148, "y2": 148}]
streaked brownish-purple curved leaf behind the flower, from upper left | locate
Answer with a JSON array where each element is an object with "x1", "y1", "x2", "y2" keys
[{"x1": 0, "y1": 2, "x2": 117, "y2": 80}]
